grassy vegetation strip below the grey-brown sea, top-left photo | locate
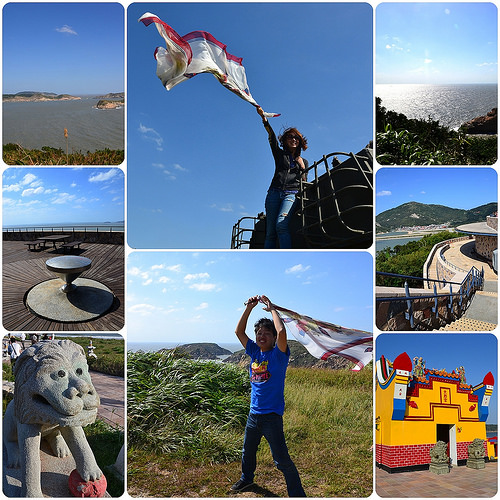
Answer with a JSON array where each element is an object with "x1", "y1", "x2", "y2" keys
[{"x1": 3, "y1": 143, "x2": 124, "y2": 165}]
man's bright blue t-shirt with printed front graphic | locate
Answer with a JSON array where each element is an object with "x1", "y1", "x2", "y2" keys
[{"x1": 246, "y1": 339, "x2": 290, "y2": 415}]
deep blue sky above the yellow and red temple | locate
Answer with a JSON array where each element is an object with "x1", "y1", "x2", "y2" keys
[{"x1": 375, "y1": 333, "x2": 498, "y2": 424}]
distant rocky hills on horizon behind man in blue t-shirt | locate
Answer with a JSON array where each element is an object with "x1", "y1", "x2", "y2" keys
[{"x1": 150, "y1": 340, "x2": 352, "y2": 370}]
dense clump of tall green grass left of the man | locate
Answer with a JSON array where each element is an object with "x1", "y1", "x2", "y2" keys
[{"x1": 127, "y1": 350, "x2": 249, "y2": 462}]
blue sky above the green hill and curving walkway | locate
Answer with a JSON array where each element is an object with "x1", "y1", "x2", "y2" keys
[{"x1": 375, "y1": 167, "x2": 498, "y2": 215}]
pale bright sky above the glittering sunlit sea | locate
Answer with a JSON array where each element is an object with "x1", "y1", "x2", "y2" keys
[{"x1": 375, "y1": 2, "x2": 498, "y2": 84}]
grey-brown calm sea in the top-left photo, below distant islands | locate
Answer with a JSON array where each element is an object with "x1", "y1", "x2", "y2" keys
[{"x1": 2, "y1": 96, "x2": 125, "y2": 153}]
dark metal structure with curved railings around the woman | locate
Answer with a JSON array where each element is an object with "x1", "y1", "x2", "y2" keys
[{"x1": 231, "y1": 148, "x2": 373, "y2": 249}]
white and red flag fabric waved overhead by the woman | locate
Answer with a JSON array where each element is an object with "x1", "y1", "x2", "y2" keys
[{"x1": 139, "y1": 12, "x2": 279, "y2": 117}]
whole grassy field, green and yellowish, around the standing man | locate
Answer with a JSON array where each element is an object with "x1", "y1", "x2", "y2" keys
[{"x1": 128, "y1": 351, "x2": 372, "y2": 497}]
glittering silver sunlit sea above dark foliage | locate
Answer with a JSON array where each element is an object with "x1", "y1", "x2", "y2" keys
[{"x1": 375, "y1": 83, "x2": 498, "y2": 129}]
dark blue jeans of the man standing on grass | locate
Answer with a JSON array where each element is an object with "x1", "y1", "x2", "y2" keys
[{"x1": 241, "y1": 413, "x2": 306, "y2": 497}]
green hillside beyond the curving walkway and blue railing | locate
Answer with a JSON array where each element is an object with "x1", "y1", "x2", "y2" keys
[{"x1": 375, "y1": 201, "x2": 497, "y2": 233}]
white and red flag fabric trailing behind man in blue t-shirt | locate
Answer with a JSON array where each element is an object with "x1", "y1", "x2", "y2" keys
[{"x1": 274, "y1": 305, "x2": 373, "y2": 371}]
